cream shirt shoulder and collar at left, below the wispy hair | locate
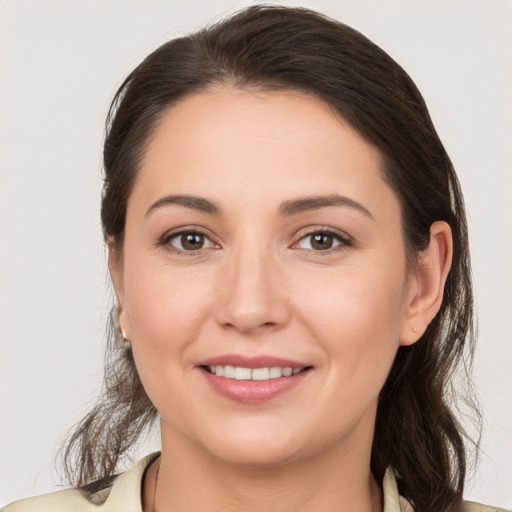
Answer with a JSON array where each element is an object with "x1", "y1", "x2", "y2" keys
[{"x1": 0, "y1": 453, "x2": 159, "y2": 512}]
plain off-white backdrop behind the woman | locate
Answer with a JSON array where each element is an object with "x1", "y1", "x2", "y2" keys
[{"x1": 0, "y1": 0, "x2": 512, "y2": 507}]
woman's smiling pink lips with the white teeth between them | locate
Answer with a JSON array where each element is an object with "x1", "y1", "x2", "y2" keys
[{"x1": 199, "y1": 355, "x2": 312, "y2": 404}]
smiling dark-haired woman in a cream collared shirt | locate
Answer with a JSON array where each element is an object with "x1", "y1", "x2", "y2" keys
[{"x1": 5, "y1": 7, "x2": 508, "y2": 512}]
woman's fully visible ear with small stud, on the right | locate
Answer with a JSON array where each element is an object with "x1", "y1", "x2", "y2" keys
[{"x1": 400, "y1": 221, "x2": 453, "y2": 345}]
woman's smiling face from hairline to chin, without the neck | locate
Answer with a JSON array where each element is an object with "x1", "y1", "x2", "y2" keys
[{"x1": 111, "y1": 86, "x2": 413, "y2": 465}]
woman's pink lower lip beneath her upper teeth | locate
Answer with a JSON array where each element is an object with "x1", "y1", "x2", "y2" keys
[{"x1": 201, "y1": 368, "x2": 311, "y2": 404}]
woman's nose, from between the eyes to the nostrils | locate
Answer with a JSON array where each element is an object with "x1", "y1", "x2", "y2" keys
[{"x1": 216, "y1": 242, "x2": 290, "y2": 335}]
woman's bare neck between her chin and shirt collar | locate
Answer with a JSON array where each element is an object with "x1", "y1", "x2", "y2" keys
[{"x1": 143, "y1": 422, "x2": 383, "y2": 512}]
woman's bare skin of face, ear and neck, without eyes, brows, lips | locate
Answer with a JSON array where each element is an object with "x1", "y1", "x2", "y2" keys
[{"x1": 109, "y1": 86, "x2": 451, "y2": 511}]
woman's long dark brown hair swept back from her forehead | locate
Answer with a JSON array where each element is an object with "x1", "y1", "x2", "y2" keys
[{"x1": 65, "y1": 6, "x2": 476, "y2": 512}]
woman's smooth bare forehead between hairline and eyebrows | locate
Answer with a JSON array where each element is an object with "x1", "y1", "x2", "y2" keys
[{"x1": 134, "y1": 85, "x2": 394, "y2": 216}]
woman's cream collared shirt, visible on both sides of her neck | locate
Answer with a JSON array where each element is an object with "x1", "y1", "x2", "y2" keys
[{"x1": 0, "y1": 453, "x2": 506, "y2": 512}]
